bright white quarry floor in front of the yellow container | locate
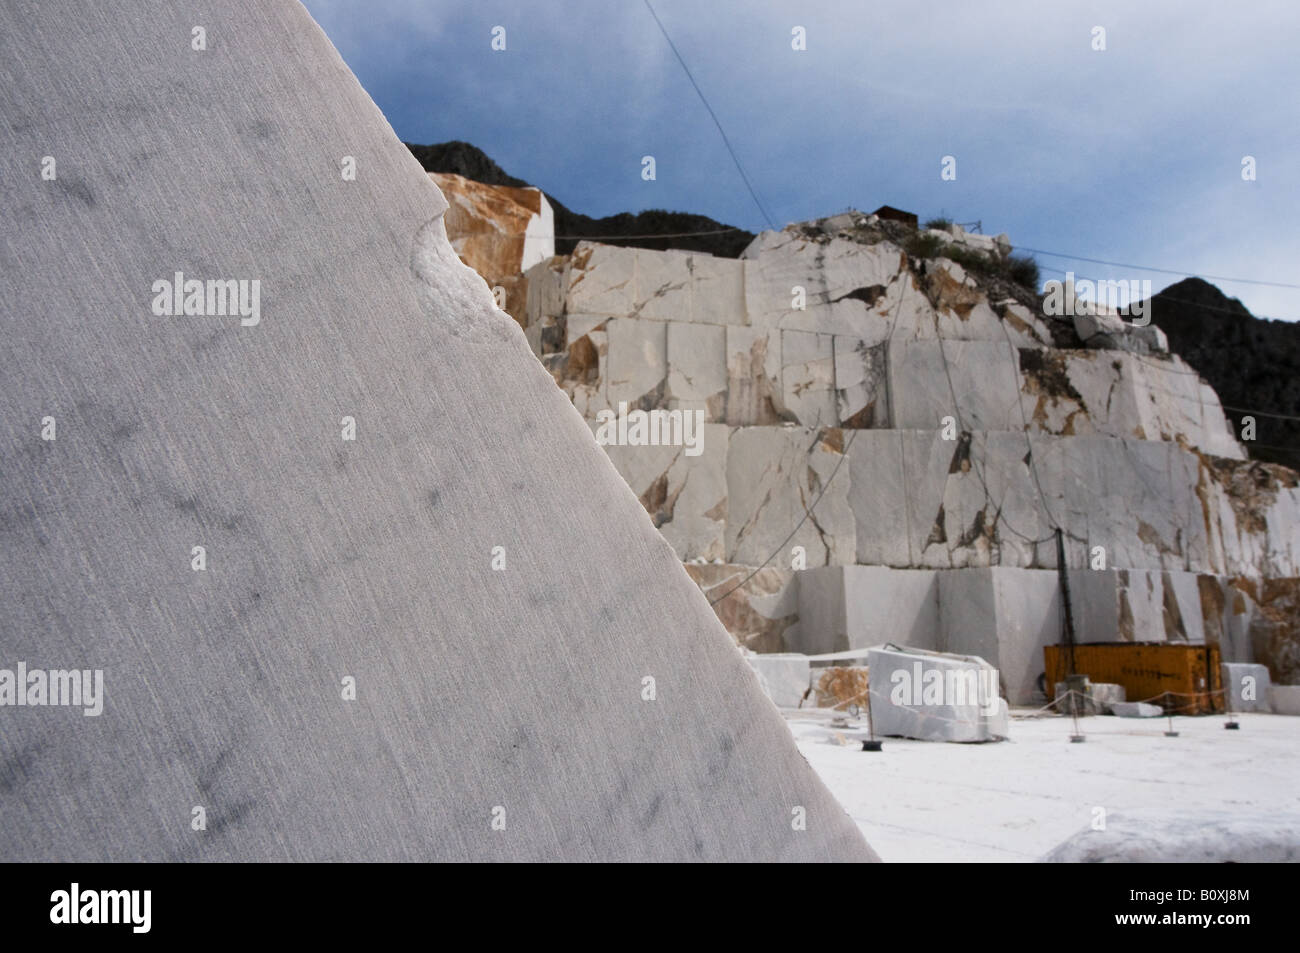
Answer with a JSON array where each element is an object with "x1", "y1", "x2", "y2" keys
[{"x1": 783, "y1": 709, "x2": 1300, "y2": 862}]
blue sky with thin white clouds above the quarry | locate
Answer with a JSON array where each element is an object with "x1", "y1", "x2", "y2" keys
[{"x1": 307, "y1": 0, "x2": 1300, "y2": 320}]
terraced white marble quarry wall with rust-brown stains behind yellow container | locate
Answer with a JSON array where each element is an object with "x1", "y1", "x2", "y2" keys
[{"x1": 525, "y1": 229, "x2": 1300, "y2": 703}]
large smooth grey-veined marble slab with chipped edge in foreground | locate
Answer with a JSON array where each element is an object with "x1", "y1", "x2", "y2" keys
[{"x1": 0, "y1": 0, "x2": 875, "y2": 861}]
